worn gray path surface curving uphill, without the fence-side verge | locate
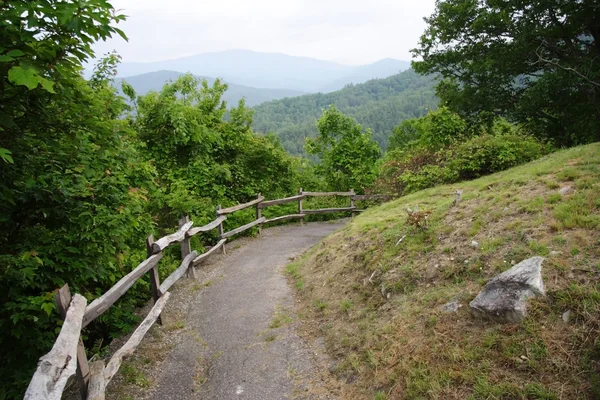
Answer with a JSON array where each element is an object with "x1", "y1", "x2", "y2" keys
[{"x1": 142, "y1": 221, "x2": 346, "y2": 400}]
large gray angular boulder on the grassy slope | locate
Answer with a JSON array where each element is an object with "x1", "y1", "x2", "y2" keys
[{"x1": 469, "y1": 257, "x2": 546, "y2": 322}]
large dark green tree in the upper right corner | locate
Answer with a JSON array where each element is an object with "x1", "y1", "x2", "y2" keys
[{"x1": 413, "y1": 0, "x2": 600, "y2": 145}]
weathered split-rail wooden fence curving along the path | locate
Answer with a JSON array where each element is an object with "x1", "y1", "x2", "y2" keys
[{"x1": 25, "y1": 189, "x2": 392, "y2": 400}]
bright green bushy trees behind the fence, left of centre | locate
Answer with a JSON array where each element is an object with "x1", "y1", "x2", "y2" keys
[{"x1": 125, "y1": 74, "x2": 301, "y2": 228}]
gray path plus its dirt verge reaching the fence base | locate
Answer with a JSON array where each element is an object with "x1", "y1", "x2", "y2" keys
[{"x1": 107, "y1": 220, "x2": 347, "y2": 400}]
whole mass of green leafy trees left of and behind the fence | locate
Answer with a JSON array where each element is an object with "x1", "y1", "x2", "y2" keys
[{"x1": 0, "y1": 0, "x2": 310, "y2": 399}]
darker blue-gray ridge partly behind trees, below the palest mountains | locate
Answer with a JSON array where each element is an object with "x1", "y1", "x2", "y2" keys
[{"x1": 114, "y1": 71, "x2": 304, "y2": 107}]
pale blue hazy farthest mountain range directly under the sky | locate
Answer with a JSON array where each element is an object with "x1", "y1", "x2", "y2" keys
[{"x1": 118, "y1": 50, "x2": 410, "y2": 93}]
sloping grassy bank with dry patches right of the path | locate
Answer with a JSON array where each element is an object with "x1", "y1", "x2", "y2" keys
[{"x1": 288, "y1": 144, "x2": 600, "y2": 400}]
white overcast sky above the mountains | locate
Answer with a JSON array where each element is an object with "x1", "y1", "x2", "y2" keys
[{"x1": 95, "y1": 0, "x2": 435, "y2": 64}]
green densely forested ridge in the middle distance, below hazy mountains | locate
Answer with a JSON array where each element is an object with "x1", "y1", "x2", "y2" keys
[{"x1": 253, "y1": 70, "x2": 438, "y2": 154}]
